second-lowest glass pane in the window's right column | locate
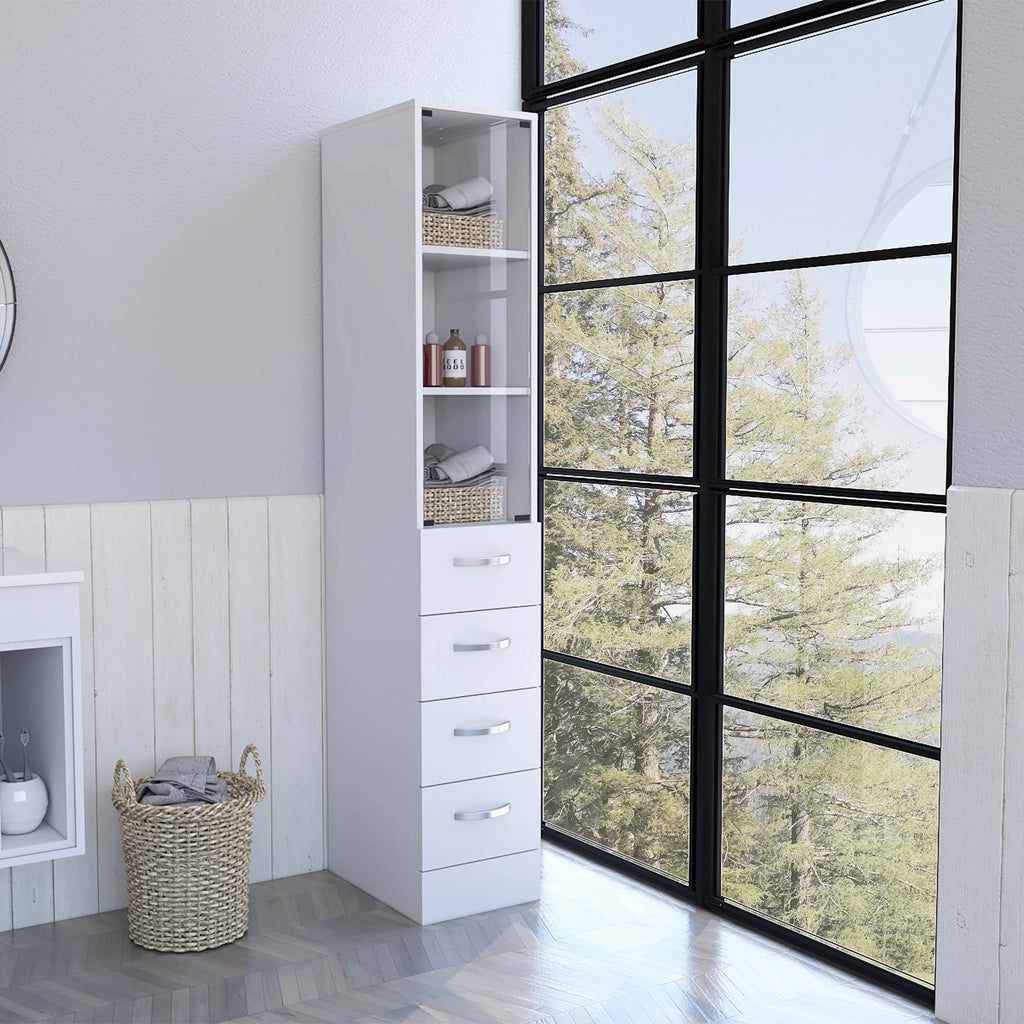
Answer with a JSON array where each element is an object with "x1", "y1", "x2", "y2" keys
[{"x1": 725, "y1": 498, "x2": 945, "y2": 743}]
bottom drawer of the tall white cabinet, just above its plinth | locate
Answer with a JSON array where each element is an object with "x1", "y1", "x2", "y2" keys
[{"x1": 422, "y1": 771, "x2": 541, "y2": 871}]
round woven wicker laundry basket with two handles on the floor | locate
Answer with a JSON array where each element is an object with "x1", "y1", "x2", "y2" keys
[{"x1": 111, "y1": 743, "x2": 266, "y2": 952}]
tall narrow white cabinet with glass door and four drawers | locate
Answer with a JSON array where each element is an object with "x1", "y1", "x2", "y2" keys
[{"x1": 323, "y1": 101, "x2": 541, "y2": 924}]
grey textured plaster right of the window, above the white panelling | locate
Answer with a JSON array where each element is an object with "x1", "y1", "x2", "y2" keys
[{"x1": 952, "y1": 0, "x2": 1024, "y2": 487}]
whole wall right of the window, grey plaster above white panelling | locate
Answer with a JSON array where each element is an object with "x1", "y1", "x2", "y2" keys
[{"x1": 936, "y1": 0, "x2": 1024, "y2": 1024}]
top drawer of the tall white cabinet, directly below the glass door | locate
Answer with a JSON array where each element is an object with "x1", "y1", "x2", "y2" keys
[{"x1": 420, "y1": 522, "x2": 541, "y2": 615}]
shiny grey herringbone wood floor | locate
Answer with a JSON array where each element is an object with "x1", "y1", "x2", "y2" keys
[{"x1": 0, "y1": 847, "x2": 935, "y2": 1024}]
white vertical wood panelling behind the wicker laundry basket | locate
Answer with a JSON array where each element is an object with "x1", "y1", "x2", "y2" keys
[{"x1": 0, "y1": 495, "x2": 325, "y2": 931}]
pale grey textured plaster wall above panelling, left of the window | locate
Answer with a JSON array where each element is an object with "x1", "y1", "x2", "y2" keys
[{"x1": 0, "y1": 0, "x2": 519, "y2": 505}]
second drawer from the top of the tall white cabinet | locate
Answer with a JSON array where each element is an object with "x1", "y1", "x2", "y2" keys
[{"x1": 420, "y1": 605, "x2": 541, "y2": 700}]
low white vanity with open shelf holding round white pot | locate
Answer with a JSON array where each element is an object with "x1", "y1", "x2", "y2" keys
[{"x1": 0, "y1": 548, "x2": 85, "y2": 867}]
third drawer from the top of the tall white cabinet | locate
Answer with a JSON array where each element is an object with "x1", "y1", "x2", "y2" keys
[{"x1": 421, "y1": 687, "x2": 541, "y2": 785}]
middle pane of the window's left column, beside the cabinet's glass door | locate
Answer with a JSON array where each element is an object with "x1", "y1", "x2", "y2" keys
[{"x1": 544, "y1": 281, "x2": 693, "y2": 476}]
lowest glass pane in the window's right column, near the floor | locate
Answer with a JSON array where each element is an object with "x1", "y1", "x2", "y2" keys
[{"x1": 722, "y1": 709, "x2": 939, "y2": 984}]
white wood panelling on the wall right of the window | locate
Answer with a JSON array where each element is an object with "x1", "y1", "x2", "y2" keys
[{"x1": 935, "y1": 487, "x2": 1024, "y2": 1024}]
